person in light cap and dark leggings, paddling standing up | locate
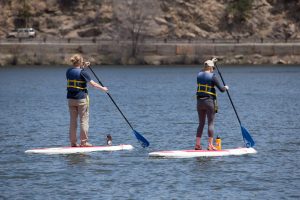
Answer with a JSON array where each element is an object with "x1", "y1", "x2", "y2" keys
[{"x1": 195, "y1": 59, "x2": 229, "y2": 150}]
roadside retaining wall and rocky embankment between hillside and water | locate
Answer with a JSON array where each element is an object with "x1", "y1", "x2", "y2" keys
[{"x1": 0, "y1": 40, "x2": 300, "y2": 66}]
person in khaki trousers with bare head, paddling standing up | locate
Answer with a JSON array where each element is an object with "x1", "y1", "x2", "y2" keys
[{"x1": 66, "y1": 54, "x2": 108, "y2": 147}]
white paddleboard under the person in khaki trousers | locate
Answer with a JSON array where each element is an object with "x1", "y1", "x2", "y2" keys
[{"x1": 25, "y1": 144, "x2": 133, "y2": 154}]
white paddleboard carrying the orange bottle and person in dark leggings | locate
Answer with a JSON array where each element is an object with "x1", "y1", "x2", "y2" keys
[{"x1": 149, "y1": 148, "x2": 257, "y2": 158}]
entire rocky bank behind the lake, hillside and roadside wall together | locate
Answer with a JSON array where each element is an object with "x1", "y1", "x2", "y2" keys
[{"x1": 0, "y1": 0, "x2": 300, "y2": 66}]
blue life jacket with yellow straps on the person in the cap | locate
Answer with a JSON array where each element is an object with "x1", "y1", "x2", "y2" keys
[{"x1": 197, "y1": 72, "x2": 217, "y2": 99}]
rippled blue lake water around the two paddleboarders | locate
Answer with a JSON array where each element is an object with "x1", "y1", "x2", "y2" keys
[{"x1": 0, "y1": 66, "x2": 300, "y2": 200}]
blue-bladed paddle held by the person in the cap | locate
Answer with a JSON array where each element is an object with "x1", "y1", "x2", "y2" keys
[{"x1": 212, "y1": 58, "x2": 255, "y2": 147}]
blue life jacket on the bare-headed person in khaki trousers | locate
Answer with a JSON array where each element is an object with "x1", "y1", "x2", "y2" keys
[{"x1": 66, "y1": 68, "x2": 88, "y2": 99}]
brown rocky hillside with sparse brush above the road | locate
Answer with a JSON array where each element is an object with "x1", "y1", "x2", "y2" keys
[{"x1": 0, "y1": 0, "x2": 300, "y2": 39}]
